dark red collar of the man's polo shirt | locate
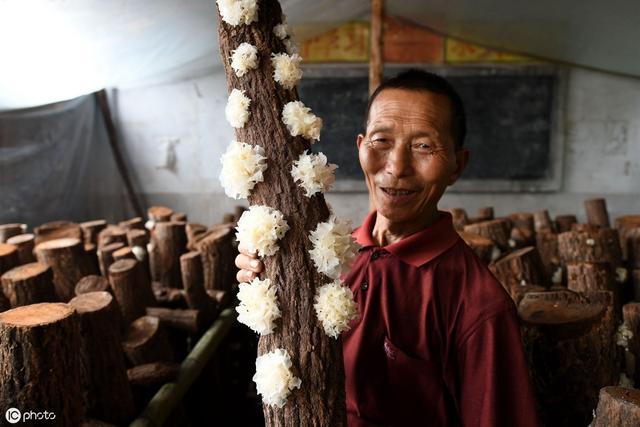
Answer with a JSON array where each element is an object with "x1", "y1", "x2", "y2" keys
[{"x1": 352, "y1": 211, "x2": 460, "y2": 267}]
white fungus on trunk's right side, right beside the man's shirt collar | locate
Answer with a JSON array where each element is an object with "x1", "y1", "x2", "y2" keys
[{"x1": 309, "y1": 216, "x2": 359, "y2": 279}]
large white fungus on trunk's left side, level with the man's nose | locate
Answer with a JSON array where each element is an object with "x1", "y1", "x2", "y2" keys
[{"x1": 219, "y1": 141, "x2": 267, "y2": 199}]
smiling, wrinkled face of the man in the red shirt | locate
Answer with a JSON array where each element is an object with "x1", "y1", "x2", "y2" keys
[{"x1": 357, "y1": 89, "x2": 468, "y2": 224}]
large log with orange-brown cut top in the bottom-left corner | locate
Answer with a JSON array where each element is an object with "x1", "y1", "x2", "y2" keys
[{"x1": 0, "y1": 303, "x2": 83, "y2": 427}]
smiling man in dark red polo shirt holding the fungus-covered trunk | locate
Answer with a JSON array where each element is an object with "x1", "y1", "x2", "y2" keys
[{"x1": 236, "y1": 70, "x2": 538, "y2": 427}]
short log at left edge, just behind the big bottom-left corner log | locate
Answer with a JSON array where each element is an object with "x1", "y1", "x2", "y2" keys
[{"x1": 2, "y1": 262, "x2": 56, "y2": 307}]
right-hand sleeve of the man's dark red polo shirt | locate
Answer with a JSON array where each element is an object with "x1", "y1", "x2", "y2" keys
[{"x1": 458, "y1": 307, "x2": 539, "y2": 427}]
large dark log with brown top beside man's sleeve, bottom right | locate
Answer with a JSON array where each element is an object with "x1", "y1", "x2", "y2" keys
[{"x1": 518, "y1": 291, "x2": 618, "y2": 426}]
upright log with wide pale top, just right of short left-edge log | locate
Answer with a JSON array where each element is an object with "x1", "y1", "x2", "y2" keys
[{"x1": 36, "y1": 238, "x2": 97, "y2": 302}]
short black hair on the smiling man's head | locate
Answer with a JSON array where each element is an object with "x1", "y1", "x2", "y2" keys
[{"x1": 365, "y1": 69, "x2": 467, "y2": 149}]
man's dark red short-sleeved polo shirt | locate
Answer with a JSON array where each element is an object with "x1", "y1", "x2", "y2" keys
[{"x1": 343, "y1": 212, "x2": 538, "y2": 427}]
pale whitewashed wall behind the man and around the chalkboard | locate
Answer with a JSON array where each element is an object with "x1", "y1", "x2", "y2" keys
[{"x1": 114, "y1": 69, "x2": 640, "y2": 224}]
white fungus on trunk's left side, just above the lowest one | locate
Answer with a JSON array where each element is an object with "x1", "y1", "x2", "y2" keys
[{"x1": 236, "y1": 277, "x2": 280, "y2": 335}]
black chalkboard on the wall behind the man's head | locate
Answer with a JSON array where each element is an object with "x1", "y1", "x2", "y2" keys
[{"x1": 298, "y1": 70, "x2": 557, "y2": 181}]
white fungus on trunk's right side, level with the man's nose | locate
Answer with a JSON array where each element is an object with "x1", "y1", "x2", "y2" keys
[{"x1": 291, "y1": 151, "x2": 338, "y2": 197}]
